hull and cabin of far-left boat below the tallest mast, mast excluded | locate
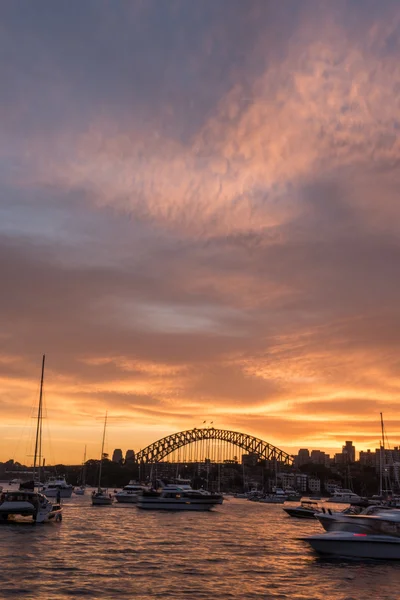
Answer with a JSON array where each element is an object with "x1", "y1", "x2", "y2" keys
[{"x1": 0, "y1": 490, "x2": 62, "y2": 523}]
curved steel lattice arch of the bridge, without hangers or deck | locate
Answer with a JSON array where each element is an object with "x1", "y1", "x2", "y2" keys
[{"x1": 136, "y1": 427, "x2": 293, "y2": 465}]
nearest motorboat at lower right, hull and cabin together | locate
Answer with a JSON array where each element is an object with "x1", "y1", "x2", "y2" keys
[{"x1": 303, "y1": 509, "x2": 400, "y2": 560}]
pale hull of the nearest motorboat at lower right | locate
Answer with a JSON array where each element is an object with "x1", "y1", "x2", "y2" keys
[{"x1": 305, "y1": 531, "x2": 400, "y2": 560}]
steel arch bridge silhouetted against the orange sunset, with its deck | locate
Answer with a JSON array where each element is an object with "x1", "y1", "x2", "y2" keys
[{"x1": 135, "y1": 427, "x2": 293, "y2": 465}]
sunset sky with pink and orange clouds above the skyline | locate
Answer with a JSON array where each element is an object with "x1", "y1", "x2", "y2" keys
[{"x1": 0, "y1": 0, "x2": 400, "y2": 464}]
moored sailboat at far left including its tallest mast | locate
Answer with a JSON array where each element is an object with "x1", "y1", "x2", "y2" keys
[{"x1": 0, "y1": 355, "x2": 62, "y2": 523}]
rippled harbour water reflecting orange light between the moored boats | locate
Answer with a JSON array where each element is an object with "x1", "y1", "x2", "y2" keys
[{"x1": 0, "y1": 494, "x2": 400, "y2": 600}]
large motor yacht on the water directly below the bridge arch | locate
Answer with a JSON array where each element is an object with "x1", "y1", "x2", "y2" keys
[{"x1": 136, "y1": 484, "x2": 223, "y2": 511}]
